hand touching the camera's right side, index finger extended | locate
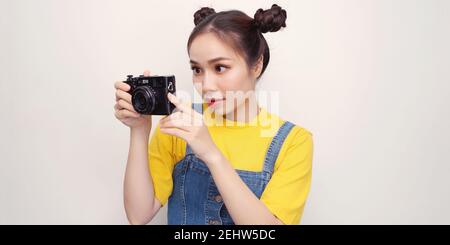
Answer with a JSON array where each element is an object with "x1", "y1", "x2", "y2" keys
[{"x1": 160, "y1": 93, "x2": 220, "y2": 163}]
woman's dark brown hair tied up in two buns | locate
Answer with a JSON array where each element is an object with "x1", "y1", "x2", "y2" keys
[{"x1": 187, "y1": 4, "x2": 287, "y2": 79}]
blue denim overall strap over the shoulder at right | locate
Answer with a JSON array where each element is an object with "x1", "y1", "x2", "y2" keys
[{"x1": 263, "y1": 121, "x2": 295, "y2": 176}]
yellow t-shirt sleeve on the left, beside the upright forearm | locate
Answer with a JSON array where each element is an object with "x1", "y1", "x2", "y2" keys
[{"x1": 148, "y1": 119, "x2": 175, "y2": 205}]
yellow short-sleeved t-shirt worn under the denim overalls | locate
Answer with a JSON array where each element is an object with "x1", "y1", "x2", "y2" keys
[{"x1": 148, "y1": 104, "x2": 313, "y2": 224}]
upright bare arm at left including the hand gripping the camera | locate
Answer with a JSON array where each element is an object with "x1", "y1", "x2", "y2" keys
[{"x1": 114, "y1": 70, "x2": 161, "y2": 224}]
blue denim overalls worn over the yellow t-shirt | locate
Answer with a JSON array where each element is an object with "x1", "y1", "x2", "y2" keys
[{"x1": 168, "y1": 103, "x2": 294, "y2": 225}]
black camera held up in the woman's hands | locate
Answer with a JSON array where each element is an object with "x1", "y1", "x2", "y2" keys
[{"x1": 124, "y1": 75, "x2": 176, "y2": 115}]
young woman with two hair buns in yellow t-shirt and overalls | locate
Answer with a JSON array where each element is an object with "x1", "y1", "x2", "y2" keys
[{"x1": 115, "y1": 4, "x2": 313, "y2": 224}]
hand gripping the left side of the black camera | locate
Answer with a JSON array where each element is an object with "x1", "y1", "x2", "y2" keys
[{"x1": 114, "y1": 70, "x2": 152, "y2": 129}]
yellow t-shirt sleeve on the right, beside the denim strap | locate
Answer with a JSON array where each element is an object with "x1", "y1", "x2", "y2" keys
[{"x1": 261, "y1": 127, "x2": 313, "y2": 224}]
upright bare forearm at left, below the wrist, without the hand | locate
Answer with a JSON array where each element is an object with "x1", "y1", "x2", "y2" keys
[{"x1": 124, "y1": 127, "x2": 161, "y2": 224}]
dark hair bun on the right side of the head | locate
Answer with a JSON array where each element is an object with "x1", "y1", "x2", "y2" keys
[{"x1": 254, "y1": 4, "x2": 287, "y2": 33}]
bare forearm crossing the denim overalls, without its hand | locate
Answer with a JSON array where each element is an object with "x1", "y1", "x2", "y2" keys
[{"x1": 203, "y1": 151, "x2": 283, "y2": 225}]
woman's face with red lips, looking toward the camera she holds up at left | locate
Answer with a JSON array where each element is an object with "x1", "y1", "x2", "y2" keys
[{"x1": 189, "y1": 33, "x2": 260, "y2": 115}]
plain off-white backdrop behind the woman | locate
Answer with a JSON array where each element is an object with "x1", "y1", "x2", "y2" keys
[{"x1": 0, "y1": 0, "x2": 450, "y2": 224}]
